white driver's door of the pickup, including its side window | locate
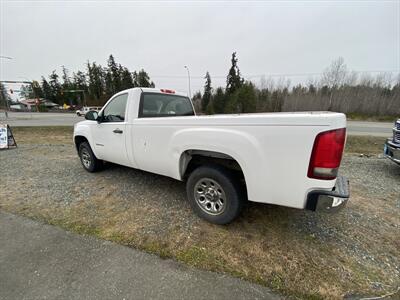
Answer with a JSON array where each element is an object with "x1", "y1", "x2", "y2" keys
[{"x1": 92, "y1": 93, "x2": 130, "y2": 166}]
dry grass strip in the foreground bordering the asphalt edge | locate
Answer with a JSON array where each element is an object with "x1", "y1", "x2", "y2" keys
[{"x1": 0, "y1": 177, "x2": 396, "y2": 299}]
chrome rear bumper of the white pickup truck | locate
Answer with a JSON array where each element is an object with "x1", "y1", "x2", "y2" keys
[{"x1": 306, "y1": 176, "x2": 350, "y2": 213}]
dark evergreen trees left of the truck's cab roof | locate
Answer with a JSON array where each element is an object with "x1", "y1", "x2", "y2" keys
[{"x1": 20, "y1": 55, "x2": 154, "y2": 106}]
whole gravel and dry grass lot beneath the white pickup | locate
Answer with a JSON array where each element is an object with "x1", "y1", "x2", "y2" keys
[{"x1": 0, "y1": 128, "x2": 400, "y2": 299}]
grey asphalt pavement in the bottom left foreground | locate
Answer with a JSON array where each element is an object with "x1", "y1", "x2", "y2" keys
[{"x1": 0, "y1": 212, "x2": 280, "y2": 299}]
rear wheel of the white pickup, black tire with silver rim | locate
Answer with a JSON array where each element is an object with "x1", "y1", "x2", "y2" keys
[{"x1": 186, "y1": 165, "x2": 245, "y2": 225}]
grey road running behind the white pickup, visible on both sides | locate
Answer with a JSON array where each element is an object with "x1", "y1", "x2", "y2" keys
[{"x1": 0, "y1": 112, "x2": 393, "y2": 137}]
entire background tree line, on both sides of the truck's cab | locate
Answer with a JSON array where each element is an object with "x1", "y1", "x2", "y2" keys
[{"x1": 0, "y1": 52, "x2": 400, "y2": 116}]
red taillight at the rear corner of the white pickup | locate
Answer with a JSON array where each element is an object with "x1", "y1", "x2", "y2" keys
[{"x1": 307, "y1": 128, "x2": 346, "y2": 180}]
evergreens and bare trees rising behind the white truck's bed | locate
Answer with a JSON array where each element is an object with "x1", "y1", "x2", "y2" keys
[{"x1": 193, "y1": 52, "x2": 400, "y2": 116}]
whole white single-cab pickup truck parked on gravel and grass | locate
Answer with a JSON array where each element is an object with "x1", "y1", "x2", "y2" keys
[{"x1": 74, "y1": 88, "x2": 349, "y2": 224}]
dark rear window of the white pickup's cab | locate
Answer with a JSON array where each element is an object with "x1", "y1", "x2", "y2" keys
[{"x1": 139, "y1": 93, "x2": 194, "y2": 118}]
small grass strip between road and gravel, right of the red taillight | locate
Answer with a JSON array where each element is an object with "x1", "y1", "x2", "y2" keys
[{"x1": 345, "y1": 135, "x2": 387, "y2": 154}]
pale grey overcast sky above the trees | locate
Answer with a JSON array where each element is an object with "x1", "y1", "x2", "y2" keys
[{"x1": 0, "y1": 0, "x2": 400, "y2": 96}]
